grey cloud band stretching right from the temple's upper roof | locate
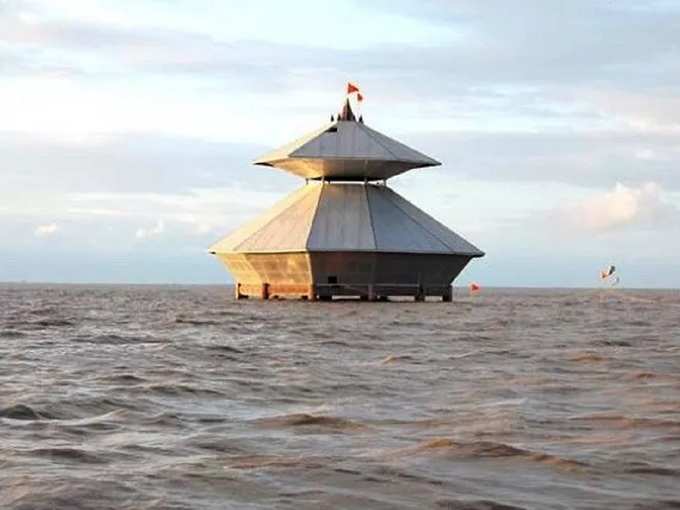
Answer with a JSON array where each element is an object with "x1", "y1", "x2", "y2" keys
[{"x1": 403, "y1": 130, "x2": 680, "y2": 190}]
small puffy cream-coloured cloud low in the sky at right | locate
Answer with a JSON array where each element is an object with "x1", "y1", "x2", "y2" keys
[{"x1": 559, "y1": 182, "x2": 680, "y2": 232}]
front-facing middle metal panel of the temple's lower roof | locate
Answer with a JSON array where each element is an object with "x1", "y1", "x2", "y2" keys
[{"x1": 307, "y1": 184, "x2": 375, "y2": 251}]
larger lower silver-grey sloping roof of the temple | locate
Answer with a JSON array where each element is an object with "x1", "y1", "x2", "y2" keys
[{"x1": 210, "y1": 182, "x2": 484, "y2": 257}]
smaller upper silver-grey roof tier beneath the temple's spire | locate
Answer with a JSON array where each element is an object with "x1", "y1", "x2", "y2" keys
[{"x1": 254, "y1": 120, "x2": 440, "y2": 181}]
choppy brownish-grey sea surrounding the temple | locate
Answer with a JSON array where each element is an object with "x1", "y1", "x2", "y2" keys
[{"x1": 0, "y1": 284, "x2": 680, "y2": 510}]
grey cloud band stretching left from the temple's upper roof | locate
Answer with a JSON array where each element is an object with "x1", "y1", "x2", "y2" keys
[{"x1": 0, "y1": 132, "x2": 291, "y2": 196}]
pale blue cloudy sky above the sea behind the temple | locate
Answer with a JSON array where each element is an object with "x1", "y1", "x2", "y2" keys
[{"x1": 0, "y1": 0, "x2": 680, "y2": 287}]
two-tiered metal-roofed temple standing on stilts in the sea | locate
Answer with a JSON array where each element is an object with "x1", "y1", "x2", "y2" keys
[{"x1": 210, "y1": 84, "x2": 484, "y2": 301}]
